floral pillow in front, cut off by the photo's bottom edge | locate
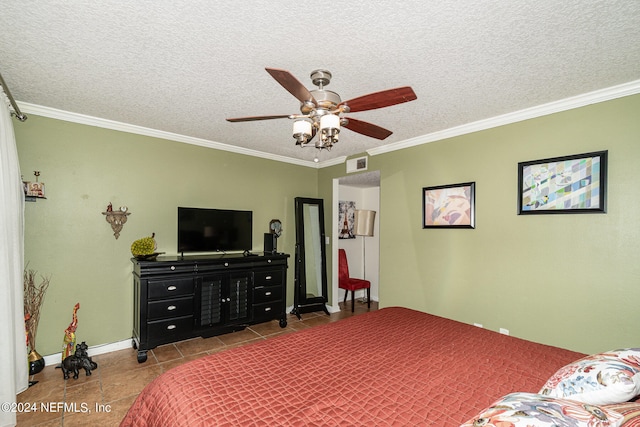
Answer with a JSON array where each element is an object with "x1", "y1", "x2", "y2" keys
[{"x1": 460, "y1": 393, "x2": 623, "y2": 427}]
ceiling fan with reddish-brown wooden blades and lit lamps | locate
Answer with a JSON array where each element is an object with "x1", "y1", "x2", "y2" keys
[{"x1": 227, "y1": 68, "x2": 418, "y2": 150}]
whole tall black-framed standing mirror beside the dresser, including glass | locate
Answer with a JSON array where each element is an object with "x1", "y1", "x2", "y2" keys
[{"x1": 291, "y1": 197, "x2": 329, "y2": 319}]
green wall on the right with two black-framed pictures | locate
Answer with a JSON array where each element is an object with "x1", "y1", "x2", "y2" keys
[{"x1": 319, "y1": 95, "x2": 640, "y2": 353}]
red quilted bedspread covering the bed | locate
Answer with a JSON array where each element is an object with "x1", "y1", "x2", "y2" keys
[{"x1": 121, "y1": 307, "x2": 584, "y2": 427}]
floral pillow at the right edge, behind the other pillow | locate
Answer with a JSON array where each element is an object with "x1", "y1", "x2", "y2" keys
[{"x1": 540, "y1": 348, "x2": 640, "y2": 405}]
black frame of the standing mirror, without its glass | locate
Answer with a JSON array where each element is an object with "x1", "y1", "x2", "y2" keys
[{"x1": 291, "y1": 197, "x2": 329, "y2": 319}]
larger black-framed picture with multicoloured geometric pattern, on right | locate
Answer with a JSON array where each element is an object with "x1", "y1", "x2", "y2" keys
[{"x1": 518, "y1": 151, "x2": 607, "y2": 215}]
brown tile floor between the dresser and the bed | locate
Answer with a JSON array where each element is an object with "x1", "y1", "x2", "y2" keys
[{"x1": 18, "y1": 301, "x2": 378, "y2": 427}]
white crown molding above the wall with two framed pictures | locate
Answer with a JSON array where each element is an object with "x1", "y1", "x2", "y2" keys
[{"x1": 367, "y1": 80, "x2": 640, "y2": 156}]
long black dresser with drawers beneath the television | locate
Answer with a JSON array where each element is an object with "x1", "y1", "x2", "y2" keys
[{"x1": 131, "y1": 253, "x2": 289, "y2": 363}]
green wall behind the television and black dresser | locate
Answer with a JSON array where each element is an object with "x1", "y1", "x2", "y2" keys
[{"x1": 14, "y1": 114, "x2": 318, "y2": 355}]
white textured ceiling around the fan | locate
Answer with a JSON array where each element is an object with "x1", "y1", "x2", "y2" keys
[{"x1": 0, "y1": 0, "x2": 640, "y2": 166}]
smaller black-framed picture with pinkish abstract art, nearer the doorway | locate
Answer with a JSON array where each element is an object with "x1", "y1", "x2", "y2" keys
[{"x1": 422, "y1": 182, "x2": 476, "y2": 228}]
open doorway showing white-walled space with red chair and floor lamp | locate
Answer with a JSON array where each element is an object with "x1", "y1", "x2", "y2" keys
[{"x1": 329, "y1": 171, "x2": 380, "y2": 311}]
